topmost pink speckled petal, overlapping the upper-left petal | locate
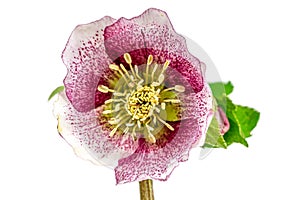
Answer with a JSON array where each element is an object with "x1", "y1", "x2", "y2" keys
[{"x1": 104, "y1": 9, "x2": 203, "y2": 92}]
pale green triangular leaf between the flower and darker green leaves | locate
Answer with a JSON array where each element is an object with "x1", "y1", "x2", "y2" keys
[{"x1": 203, "y1": 117, "x2": 227, "y2": 149}]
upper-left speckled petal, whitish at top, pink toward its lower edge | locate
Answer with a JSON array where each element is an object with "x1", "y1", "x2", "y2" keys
[{"x1": 62, "y1": 17, "x2": 115, "y2": 112}]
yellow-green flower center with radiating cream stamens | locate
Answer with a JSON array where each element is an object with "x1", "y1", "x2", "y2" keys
[{"x1": 98, "y1": 53, "x2": 185, "y2": 143}]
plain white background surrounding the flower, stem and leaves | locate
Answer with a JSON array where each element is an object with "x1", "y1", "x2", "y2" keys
[{"x1": 0, "y1": 0, "x2": 300, "y2": 200}]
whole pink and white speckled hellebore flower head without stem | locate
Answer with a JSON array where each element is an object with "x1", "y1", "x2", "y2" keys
[{"x1": 54, "y1": 9, "x2": 213, "y2": 184}]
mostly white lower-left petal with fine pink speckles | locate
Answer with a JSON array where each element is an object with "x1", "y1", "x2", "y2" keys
[{"x1": 54, "y1": 92, "x2": 138, "y2": 168}]
